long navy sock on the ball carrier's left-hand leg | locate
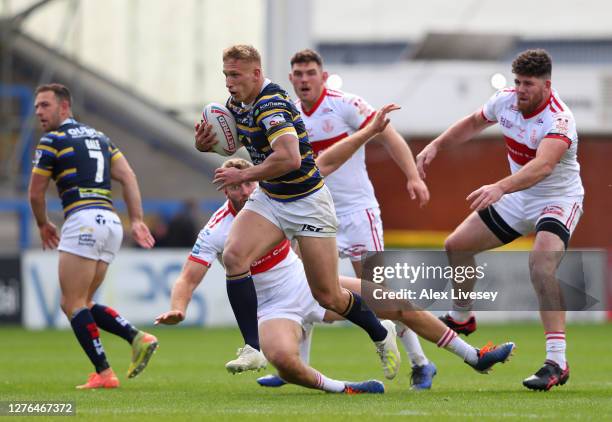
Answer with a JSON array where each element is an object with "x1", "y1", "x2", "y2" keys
[{"x1": 226, "y1": 271, "x2": 259, "y2": 350}]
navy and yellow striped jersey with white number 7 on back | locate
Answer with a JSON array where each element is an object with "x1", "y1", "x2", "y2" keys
[{"x1": 32, "y1": 119, "x2": 122, "y2": 218}]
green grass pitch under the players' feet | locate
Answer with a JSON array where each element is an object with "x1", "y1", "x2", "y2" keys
[{"x1": 0, "y1": 324, "x2": 612, "y2": 422}]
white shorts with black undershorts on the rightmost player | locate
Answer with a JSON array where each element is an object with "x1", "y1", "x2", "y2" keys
[{"x1": 479, "y1": 192, "x2": 583, "y2": 246}]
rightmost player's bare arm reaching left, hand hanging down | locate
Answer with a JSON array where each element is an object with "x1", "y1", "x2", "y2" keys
[{"x1": 416, "y1": 110, "x2": 495, "y2": 179}]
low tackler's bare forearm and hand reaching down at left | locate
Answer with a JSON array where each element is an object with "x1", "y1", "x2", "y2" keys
[{"x1": 155, "y1": 260, "x2": 208, "y2": 325}]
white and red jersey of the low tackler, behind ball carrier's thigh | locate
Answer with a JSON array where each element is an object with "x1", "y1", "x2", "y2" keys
[{"x1": 188, "y1": 201, "x2": 298, "y2": 290}]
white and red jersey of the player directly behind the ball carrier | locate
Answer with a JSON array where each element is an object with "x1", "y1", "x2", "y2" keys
[{"x1": 296, "y1": 89, "x2": 378, "y2": 216}]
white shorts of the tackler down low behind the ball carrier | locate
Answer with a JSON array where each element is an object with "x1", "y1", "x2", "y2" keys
[{"x1": 253, "y1": 259, "x2": 325, "y2": 327}]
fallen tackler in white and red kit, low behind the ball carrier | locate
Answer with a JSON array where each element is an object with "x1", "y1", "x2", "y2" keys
[{"x1": 155, "y1": 159, "x2": 514, "y2": 394}]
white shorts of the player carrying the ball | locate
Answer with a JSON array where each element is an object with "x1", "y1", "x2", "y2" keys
[{"x1": 244, "y1": 186, "x2": 338, "y2": 240}]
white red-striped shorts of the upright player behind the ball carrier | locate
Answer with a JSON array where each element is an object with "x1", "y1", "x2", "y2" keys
[{"x1": 337, "y1": 207, "x2": 385, "y2": 261}]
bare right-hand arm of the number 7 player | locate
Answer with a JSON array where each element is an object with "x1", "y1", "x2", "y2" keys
[{"x1": 111, "y1": 156, "x2": 155, "y2": 249}]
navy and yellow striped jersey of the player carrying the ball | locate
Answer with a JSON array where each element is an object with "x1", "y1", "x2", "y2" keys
[{"x1": 227, "y1": 83, "x2": 323, "y2": 202}]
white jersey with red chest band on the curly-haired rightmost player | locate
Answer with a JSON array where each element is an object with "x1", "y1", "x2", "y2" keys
[{"x1": 481, "y1": 89, "x2": 584, "y2": 196}]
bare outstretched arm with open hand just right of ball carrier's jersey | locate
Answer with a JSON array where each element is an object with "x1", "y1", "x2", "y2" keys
[{"x1": 316, "y1": 104, "x2": 401, "y2": 176}]
